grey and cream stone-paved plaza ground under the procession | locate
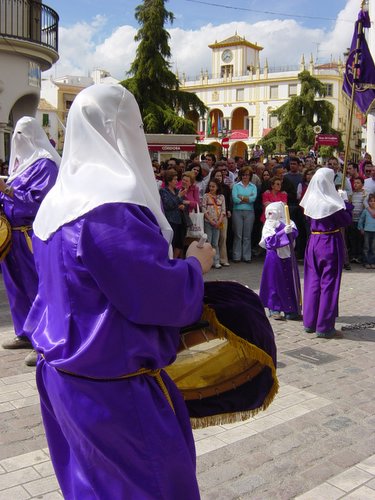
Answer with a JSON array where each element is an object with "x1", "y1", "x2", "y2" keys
[{"x1": 0, "y1": 259, "x2": 375, "y2": 500}]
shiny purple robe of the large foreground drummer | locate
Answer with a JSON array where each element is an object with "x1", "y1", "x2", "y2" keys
[{"x1": 27, "y1": 203, "x2": 203, "y2": 500}]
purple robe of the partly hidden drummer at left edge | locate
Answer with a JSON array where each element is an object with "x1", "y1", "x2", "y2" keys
[{"x1": 0, "y1": 158, "x2": 58, "y2": 336}]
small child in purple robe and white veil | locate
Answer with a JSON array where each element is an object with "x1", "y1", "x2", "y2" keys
[{"x1": 259, "y1": 201, "x2": 300, "y2": 320}]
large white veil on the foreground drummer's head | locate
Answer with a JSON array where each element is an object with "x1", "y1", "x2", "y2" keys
[{"x1": 33, "y1": 84, "x2": 173, "y2": 243}]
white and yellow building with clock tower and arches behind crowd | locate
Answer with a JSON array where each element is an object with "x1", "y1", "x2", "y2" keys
[{"x1": 181, "y1": 35, "x2": 363, "y2": 157}]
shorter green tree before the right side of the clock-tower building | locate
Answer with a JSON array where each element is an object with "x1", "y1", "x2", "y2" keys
[{"x1": 260, "y1": 71, "x2": 341, "y2": 154}]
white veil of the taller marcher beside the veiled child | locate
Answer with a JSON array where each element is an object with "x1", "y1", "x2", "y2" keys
[{"x1": 300, "y1": 167, "x2": 345, "y2": 219}]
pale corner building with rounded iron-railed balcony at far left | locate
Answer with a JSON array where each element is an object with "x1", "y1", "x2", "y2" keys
[{"x1": 0, "y1": 0, "x2": 59, "y2": 159}]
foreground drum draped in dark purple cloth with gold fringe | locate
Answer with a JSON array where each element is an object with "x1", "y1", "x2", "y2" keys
[{"x1": 166, "y1": 281, "x2": 278, "y2": 428}]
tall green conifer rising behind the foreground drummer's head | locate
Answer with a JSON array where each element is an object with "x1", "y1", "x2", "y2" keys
[{"x1": 121, "y1": 0, "x2": 207, "y2": 134}]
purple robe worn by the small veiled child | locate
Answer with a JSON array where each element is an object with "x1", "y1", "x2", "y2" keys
[{"x1": 259, "y1": 223, "x2": 299, "y2": 313}]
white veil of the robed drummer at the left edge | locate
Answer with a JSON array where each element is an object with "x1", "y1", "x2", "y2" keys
[{"x1": 7, "y1": 116, "x2": 61, "y2": 183}]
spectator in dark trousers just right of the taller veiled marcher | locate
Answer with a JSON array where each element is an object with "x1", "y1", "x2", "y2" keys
[{"x1": 348, "y1": 177, "x2": 366, "y2": 264}]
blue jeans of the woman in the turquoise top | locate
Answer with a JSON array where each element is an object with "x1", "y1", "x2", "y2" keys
[{"x1": 232, "y1": 210, "x2": 255, "y2": 261}]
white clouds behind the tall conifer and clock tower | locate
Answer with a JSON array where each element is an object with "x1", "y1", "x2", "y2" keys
[{"x1": 44, "y1": 0, "x2": 358, "y2": 79}]
